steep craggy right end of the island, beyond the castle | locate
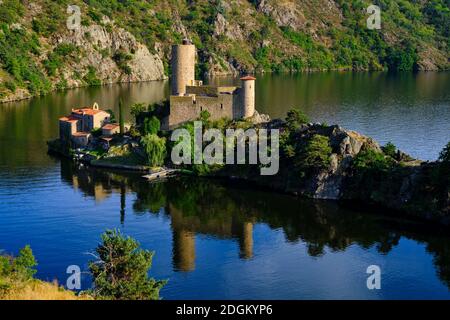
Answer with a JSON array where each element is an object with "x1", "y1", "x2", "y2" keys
[{"x1": 214, "y1": 121, "x2": 450, "y2": 225}]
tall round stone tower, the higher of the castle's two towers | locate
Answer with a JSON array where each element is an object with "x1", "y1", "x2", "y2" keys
[{"x1": 172, "y1": 39, "x2": 195, "y2": 96}]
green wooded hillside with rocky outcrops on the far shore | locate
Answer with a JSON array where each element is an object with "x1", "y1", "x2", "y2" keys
[{"x1": 0, "y1": 0, "x2": 450, "y2": 101}]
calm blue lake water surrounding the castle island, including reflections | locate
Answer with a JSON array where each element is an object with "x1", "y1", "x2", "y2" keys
[{"x1": 0, "y1": 73, "x2": 450, "y2": 299}]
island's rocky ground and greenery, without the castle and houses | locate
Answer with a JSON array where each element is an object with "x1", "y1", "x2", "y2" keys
[{"x1": 49, "y1": 102, "x2": 450, "y2": 224}]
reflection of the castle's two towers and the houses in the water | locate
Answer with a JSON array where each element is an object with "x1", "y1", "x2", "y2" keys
[{"x1": 61, "y1": 161, "x2": 255, "y2": 271}]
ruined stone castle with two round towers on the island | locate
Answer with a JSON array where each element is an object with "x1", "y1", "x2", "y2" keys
[{"x1": 162, "y1": 40, "x2": 256, "y2": 130}]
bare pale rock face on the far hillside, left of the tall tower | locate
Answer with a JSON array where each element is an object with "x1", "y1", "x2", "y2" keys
[{"x1": 0, "y1": 22, "x2": 167, "y2": 103}]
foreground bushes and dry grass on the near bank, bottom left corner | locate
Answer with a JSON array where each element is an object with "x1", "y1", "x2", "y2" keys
[{"x1": 0, "y1": 230, "x2": 167, "y2": 300}]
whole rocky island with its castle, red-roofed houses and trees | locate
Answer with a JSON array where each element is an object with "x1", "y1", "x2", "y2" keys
[{"x1": 48, "y1": 39, "x2": 450, "y2": 224}]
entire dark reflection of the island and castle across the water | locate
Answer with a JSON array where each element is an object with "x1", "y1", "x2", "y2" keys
[{"x1": 61, "y1": 161, "x2": 450, "y2": 287}]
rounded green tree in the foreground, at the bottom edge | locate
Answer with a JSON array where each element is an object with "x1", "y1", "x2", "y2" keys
[{"x1": 89, "y1": 230, "x2": 166, "y2": 300}]
